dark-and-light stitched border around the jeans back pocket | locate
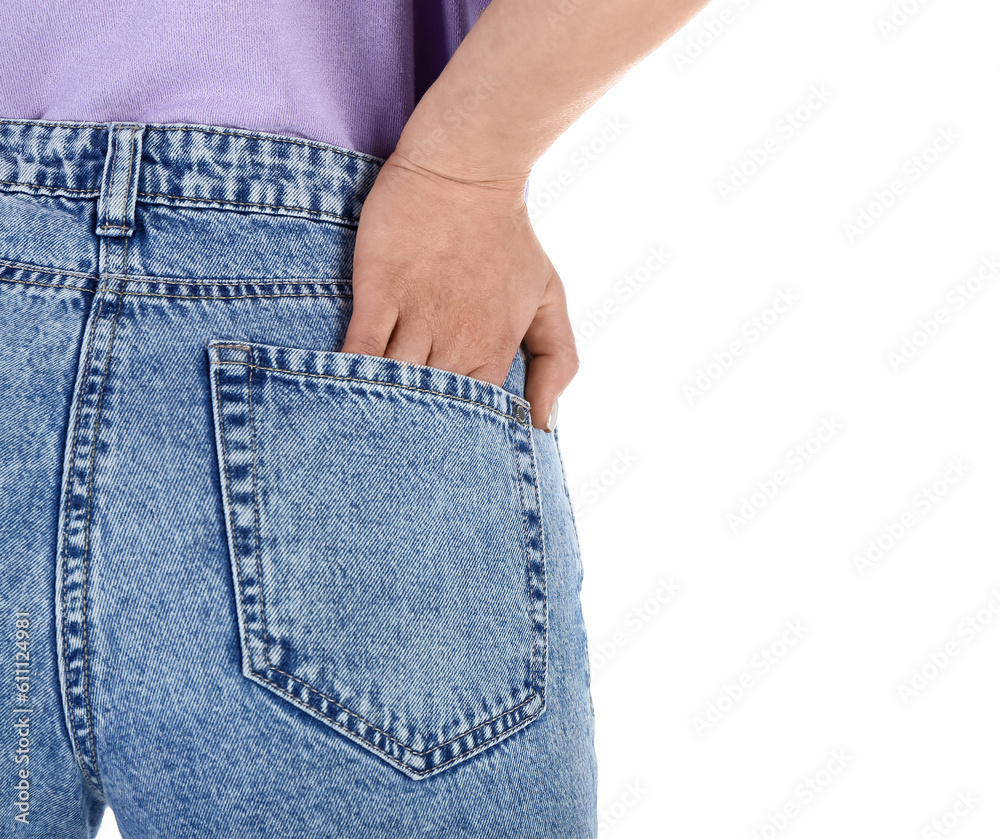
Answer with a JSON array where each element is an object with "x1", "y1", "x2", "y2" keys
[{"x1": 210, "y1": 342, "x2": 547, "y2": 777}]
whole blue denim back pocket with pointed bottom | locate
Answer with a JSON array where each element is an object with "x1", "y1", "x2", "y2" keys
[{"x1": 209, "y1": 341, "x2": 547, "y2": 778}]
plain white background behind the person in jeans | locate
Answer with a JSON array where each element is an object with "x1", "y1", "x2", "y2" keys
[{"x1": 100, "y1": 0, "x2": 1000, "y2": 839}]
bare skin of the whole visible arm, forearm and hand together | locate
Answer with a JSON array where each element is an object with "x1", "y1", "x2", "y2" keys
[{"x1": 341, "y1": 0, "x2": 707, "y2": 431}]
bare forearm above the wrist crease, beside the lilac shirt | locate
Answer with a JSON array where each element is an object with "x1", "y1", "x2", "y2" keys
[{"x1": 397, "y1": 0, "x2": 708, "y2": 187}]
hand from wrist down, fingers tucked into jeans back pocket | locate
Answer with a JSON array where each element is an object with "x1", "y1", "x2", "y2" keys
[{"x1": 341, "y1": 152, "x2": 578, "y2": 431}]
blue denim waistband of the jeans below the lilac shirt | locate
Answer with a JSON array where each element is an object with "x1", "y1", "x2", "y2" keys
[{"x1": 0, "y1": 118, "x2": 384, "y2": 226}]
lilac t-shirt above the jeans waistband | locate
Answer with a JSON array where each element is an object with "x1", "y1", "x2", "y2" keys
[{"x1": 0, "y1": 0, "x2": 489, "y2": 157}]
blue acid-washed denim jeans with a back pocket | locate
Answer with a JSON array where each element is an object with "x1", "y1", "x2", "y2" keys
[{"x1": 0, "y1": 120, "x2": 597, "y2": 839}]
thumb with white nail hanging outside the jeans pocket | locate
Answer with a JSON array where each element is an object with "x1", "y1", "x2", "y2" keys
[{"x1": 524, "y1": 274, "x2": 580, "y2": 431}]
